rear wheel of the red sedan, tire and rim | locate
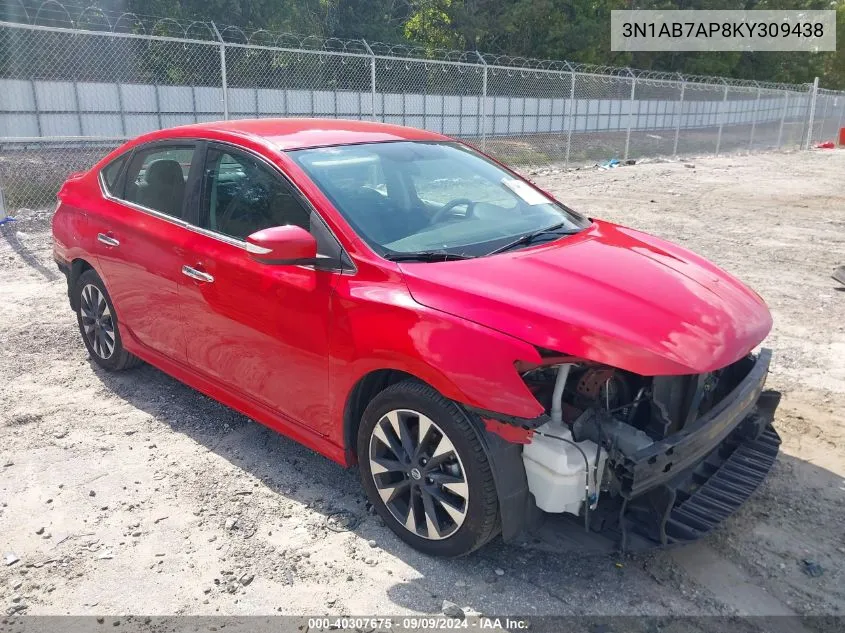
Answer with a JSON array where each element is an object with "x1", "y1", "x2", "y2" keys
[{"x1": 73, "y1": 270, "x2": 142, "y2": 371}]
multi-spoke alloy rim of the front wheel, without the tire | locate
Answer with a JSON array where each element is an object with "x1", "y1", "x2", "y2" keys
[{"x1": 369, "y1": 409, "x2": 469, "y2": 540}]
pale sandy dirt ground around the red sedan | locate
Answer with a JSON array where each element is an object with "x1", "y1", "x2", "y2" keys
[{"x1": 0, "y1": 151, "x2": 845, "y2": 630}]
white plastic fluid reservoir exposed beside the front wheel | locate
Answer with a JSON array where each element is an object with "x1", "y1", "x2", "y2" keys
[{"x1": 522, "y1": 422, "x2": 607, "y2": 515}]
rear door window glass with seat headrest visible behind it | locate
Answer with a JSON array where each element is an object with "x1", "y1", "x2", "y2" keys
[{"x1": 123, "y1": 145, "x2": 196, "y2": 218}]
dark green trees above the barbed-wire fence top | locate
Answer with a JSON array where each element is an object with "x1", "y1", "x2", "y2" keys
[{"x1": 120, "y1": 0, "x2": 845, "y2": 88}]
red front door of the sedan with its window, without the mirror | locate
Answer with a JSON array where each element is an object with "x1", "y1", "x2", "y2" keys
[{"x1": 179, "y1": 143, "x2": 342, "y2": 433}]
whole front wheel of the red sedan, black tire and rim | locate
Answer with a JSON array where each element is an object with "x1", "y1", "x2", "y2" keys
[{"x1": 357, "y1": 381, "x2": 501, "y2": 557}]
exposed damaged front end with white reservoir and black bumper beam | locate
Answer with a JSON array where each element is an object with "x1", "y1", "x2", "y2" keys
[{"x1": 498, "y1": 349, "x2": 780, "y2": 551}]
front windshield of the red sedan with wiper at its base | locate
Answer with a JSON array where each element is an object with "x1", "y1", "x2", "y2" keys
[{"x1": 289, "y1": 141, "x2": 589, "y2": 257}]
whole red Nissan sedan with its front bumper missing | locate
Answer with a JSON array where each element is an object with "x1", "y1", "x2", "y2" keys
[{"x1": 53, "y1": 119, "x2": 779, "y2": 556}]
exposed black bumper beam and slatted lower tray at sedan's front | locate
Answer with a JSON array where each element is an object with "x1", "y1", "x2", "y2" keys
[{"x1": 508, "y1": 349, "x2": 780, "y2": 551}]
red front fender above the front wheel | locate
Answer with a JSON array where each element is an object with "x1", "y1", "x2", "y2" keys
[{"x1": 329, "y1": 279, "x2": 543, "y2": 440}]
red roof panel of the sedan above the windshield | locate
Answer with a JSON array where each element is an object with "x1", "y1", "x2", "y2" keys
[{"x1": 153, "y1": 118, "x2": 451, "y2": 150}]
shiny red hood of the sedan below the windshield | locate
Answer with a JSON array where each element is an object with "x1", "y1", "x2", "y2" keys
[{"x1": 400, "y1": 221, "x2": 772, "y2": 376}]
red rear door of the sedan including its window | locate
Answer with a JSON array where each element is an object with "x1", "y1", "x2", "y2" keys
[{"x1": 89, "y1": 142, "x2": 198, "y2": 362}]
